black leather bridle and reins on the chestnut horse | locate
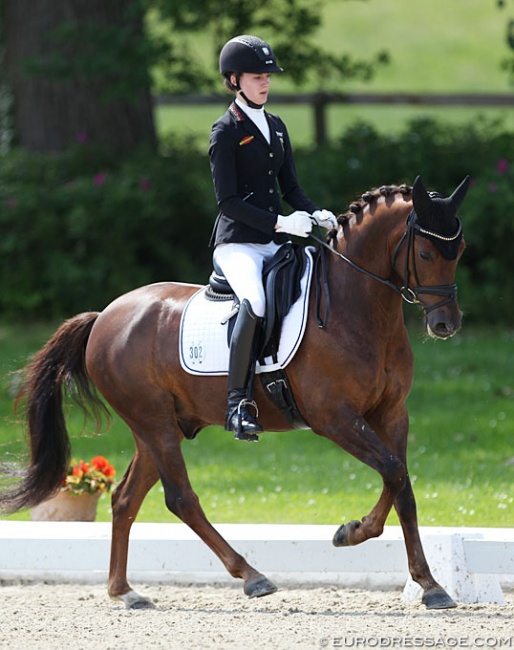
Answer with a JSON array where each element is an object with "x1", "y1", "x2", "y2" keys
[{"x1": 310, "y1": 209, "x2": 462, "y2": 328}]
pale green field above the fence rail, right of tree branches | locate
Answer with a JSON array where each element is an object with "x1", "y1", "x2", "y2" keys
[{"x1": 312, "y1": 0, "x2": 512, "y2": 92}]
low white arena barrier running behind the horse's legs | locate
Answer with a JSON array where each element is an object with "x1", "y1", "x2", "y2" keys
[{"x1": 0, "y1": 521, "x2": 514, "y2": 603}]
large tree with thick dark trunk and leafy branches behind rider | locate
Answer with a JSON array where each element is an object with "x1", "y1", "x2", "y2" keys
[{"x1": 0, "y1": 0, "x2": 387, "y2": 153}]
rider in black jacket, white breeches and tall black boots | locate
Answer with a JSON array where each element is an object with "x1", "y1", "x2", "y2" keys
[{"x1": 209, "y1": 35, "x2": 337, "y2": 441}]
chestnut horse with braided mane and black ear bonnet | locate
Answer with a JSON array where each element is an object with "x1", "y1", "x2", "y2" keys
[{"x1": 0, "y1": 176, "x2": 469, "y2": 609}]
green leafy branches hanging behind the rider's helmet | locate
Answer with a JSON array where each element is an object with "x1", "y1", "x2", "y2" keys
[{"x1": 148, "y1": 0, "x2": 388, "y2": 91}]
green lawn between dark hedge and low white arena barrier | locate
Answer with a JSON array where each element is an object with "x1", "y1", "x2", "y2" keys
[{"x1": 0, "y1": 321, "x2": 514, "y2": 527}]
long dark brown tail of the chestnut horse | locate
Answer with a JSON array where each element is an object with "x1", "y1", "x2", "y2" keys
[{"x1": 0, "y1": 312, "x2": 107, "y2": 513}]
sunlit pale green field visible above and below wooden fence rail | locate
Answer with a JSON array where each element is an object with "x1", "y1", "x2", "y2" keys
[{"x1": 155, "y1": 0, "x2": 514, "y2": 149}]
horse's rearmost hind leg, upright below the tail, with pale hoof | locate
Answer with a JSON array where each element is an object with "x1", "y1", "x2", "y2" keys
[{"x1": 108, "y1": 445, "x2": 159, "y2": 609}]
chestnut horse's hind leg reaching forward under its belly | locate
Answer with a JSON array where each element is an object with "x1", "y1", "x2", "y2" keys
[{"x1": 158, "y1": 444, "x2": 277, "y2": 598}]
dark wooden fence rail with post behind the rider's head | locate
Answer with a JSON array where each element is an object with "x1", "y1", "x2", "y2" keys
[{"x1": 154, "y1": 92, "x2": 514, "y2": 145}]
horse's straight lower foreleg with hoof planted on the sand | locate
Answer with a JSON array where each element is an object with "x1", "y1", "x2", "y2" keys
[{"x1": 394, "y1": 477, "x2": 457, "y2": 609}]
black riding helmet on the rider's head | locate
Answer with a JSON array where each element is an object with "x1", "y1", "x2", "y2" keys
[{"x1": 220, "y1": 35, "x2": 282, "y2": 76}]
